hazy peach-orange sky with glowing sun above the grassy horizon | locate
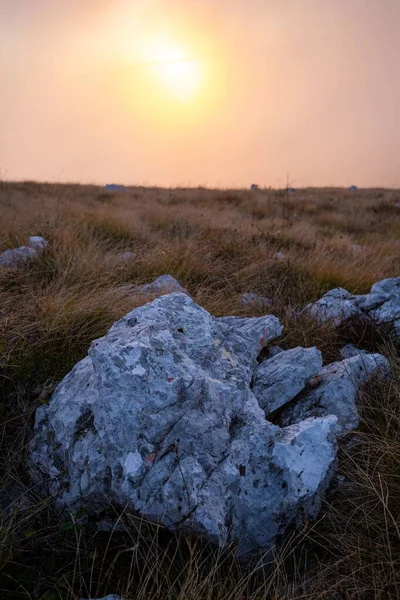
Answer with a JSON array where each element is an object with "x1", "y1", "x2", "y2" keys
[{"x1": 0, "y1": 0, "x2": 400, "y2": 187}]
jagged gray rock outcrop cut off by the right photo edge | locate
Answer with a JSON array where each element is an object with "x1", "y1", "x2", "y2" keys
[{"x1": 304, "y1": 277, "x2": 400, "y2": 335}]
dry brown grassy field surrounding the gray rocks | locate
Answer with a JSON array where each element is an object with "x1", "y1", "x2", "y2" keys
[{"x1": 0, "y1": 182, "x2": 400, "y2": 600}]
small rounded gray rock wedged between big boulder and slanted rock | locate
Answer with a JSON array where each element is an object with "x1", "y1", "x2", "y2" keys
[{"x1": 253, "y1": 347, "x2": 322, "y2": 415}]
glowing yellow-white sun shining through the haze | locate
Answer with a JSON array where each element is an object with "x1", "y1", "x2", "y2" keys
[{"x1": 142, "y1": 38, "x2": 205, "y2": 103}]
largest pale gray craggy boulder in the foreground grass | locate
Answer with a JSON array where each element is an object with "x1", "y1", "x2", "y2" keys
[{"x1": 31, "y1": 293, "x2": 337, "y2": 557}]
